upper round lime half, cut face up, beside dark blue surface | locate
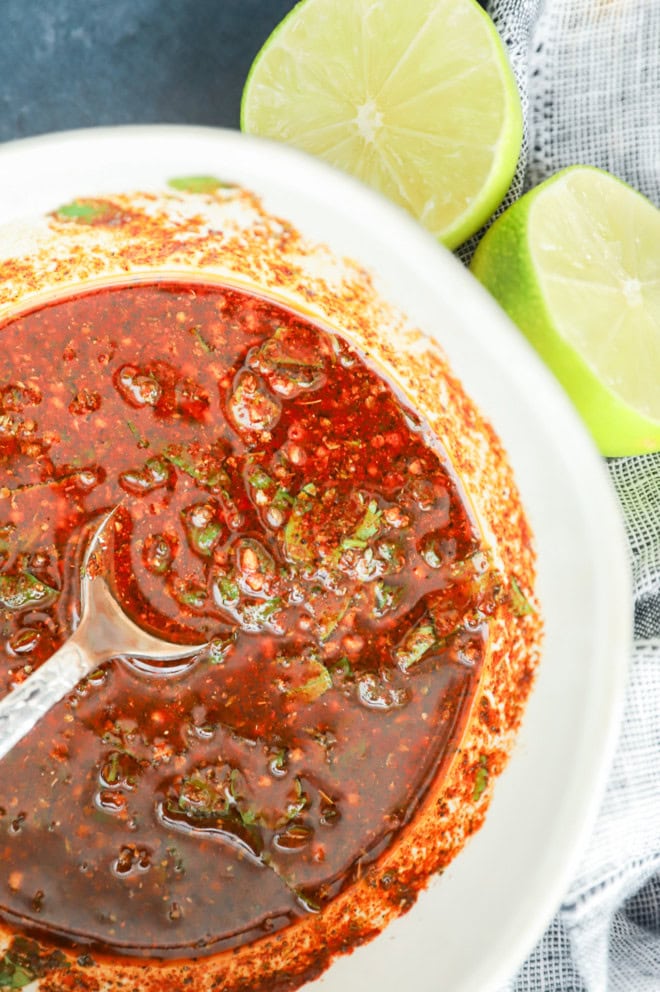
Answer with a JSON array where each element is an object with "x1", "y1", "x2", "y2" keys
[{"x1": 241, "y1": 0, "x2": 522, "y2": 247}]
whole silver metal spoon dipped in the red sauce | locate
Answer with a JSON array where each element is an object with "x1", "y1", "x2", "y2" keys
[{"x1": 0, "y1": 507, "x2": 204, "y2": 758}]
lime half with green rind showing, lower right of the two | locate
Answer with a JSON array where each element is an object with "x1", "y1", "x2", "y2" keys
[{"x1": 472, "y1": 166, "x2": 660, "y2": 455}]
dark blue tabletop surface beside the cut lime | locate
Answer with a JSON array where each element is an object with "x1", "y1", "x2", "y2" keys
[{"x1": 0, "y1": 0, "x2": 294, "y2": 141}]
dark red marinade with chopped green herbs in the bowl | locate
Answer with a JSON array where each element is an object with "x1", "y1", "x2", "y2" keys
[{"x1": 0, "y1": 283, "x2": 496, "y2": 958}]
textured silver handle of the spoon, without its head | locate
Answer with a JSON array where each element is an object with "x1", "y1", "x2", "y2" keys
[{"x1": 0, "y1": 638, "x2": 98, "y2": 758}]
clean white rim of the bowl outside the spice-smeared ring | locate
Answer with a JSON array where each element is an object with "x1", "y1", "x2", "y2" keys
[{"x1": 0, "y1": 127, "x2": 632, "y2": 992}]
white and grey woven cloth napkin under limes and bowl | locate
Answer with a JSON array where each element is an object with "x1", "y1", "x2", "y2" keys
[{"x1": 488, "y1": 0, "x2": 660, "y2": 992}]
